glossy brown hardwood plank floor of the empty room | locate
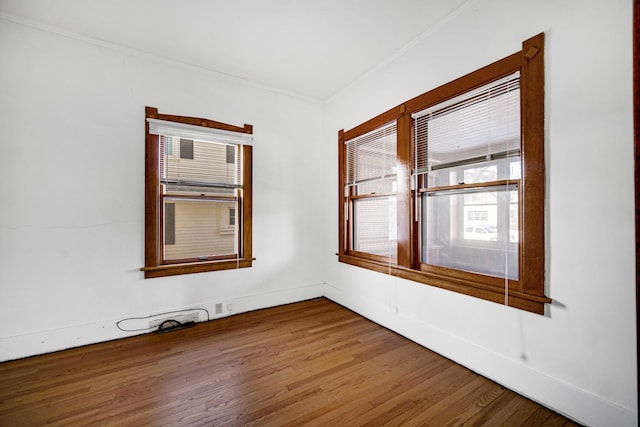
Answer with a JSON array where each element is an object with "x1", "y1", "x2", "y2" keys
[{"x1": 0, "y1": 298, "x2": 576, "y2": 427}]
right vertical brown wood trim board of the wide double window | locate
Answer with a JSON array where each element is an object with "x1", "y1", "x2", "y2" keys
[{"x1": 519, "y1": 33, "x2": 545, "y2": 295}]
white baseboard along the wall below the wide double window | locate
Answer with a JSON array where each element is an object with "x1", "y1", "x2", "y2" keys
[{"x1": 325, "y1": 284, "x2": 637, "y2": 426}]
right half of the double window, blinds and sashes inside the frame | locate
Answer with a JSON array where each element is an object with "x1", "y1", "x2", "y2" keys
[{"x1": 412, "y1": 72, "x2": 521, "y2": 280}]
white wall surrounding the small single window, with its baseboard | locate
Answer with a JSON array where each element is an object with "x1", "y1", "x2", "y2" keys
[{"x1": 0, "y1": 19, "x2": 324, "y2": 360}]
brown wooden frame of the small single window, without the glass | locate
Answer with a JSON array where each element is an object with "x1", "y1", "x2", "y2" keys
[{"x1": 141, "y1": 107, "x2": 253, "y2": 279}]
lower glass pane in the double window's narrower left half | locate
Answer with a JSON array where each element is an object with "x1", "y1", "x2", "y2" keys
[{"x1": 353, "y1": 196, "x2": 398, "y2": 258}]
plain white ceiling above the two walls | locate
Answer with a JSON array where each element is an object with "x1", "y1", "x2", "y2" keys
[{"x1": 0, "y1": 0, "x2": 469, "y2": 101}]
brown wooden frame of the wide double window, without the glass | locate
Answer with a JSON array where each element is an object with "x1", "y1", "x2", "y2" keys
[{"x1": 338, "y1": 33, "x2": 551, "y2": 314}]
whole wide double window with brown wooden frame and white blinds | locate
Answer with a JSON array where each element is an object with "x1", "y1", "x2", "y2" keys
[{"x1": 338, "y1": 34, "x2": 551, "y2": 313}]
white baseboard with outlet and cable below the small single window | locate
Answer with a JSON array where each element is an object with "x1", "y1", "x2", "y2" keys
[{"x1": 0, "y1": 283, "x2": 324, "y2": 362}]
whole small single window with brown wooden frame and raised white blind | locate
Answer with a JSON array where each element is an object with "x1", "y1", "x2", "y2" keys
[{"x1": 142, "y1": 107, "x2": 253, "y2": 278}]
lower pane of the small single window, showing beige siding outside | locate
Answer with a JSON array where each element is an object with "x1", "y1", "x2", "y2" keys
[{"x1": 164, "y1": 199, "x2": 238, "y2": 260}]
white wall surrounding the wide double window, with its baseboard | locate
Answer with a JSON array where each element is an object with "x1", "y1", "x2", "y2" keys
[{"x1": 324, "y1": 0, "x2": 637, "y2": 426}]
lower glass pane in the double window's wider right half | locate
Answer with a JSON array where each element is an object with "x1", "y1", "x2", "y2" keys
[{"x1": 422, "y1": 186, "x2": 518, "y2": 280}]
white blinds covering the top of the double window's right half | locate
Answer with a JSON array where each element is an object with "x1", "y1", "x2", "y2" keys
[{"x1": 412, "y1": 72, "x2": 520, "y2": 174}]
